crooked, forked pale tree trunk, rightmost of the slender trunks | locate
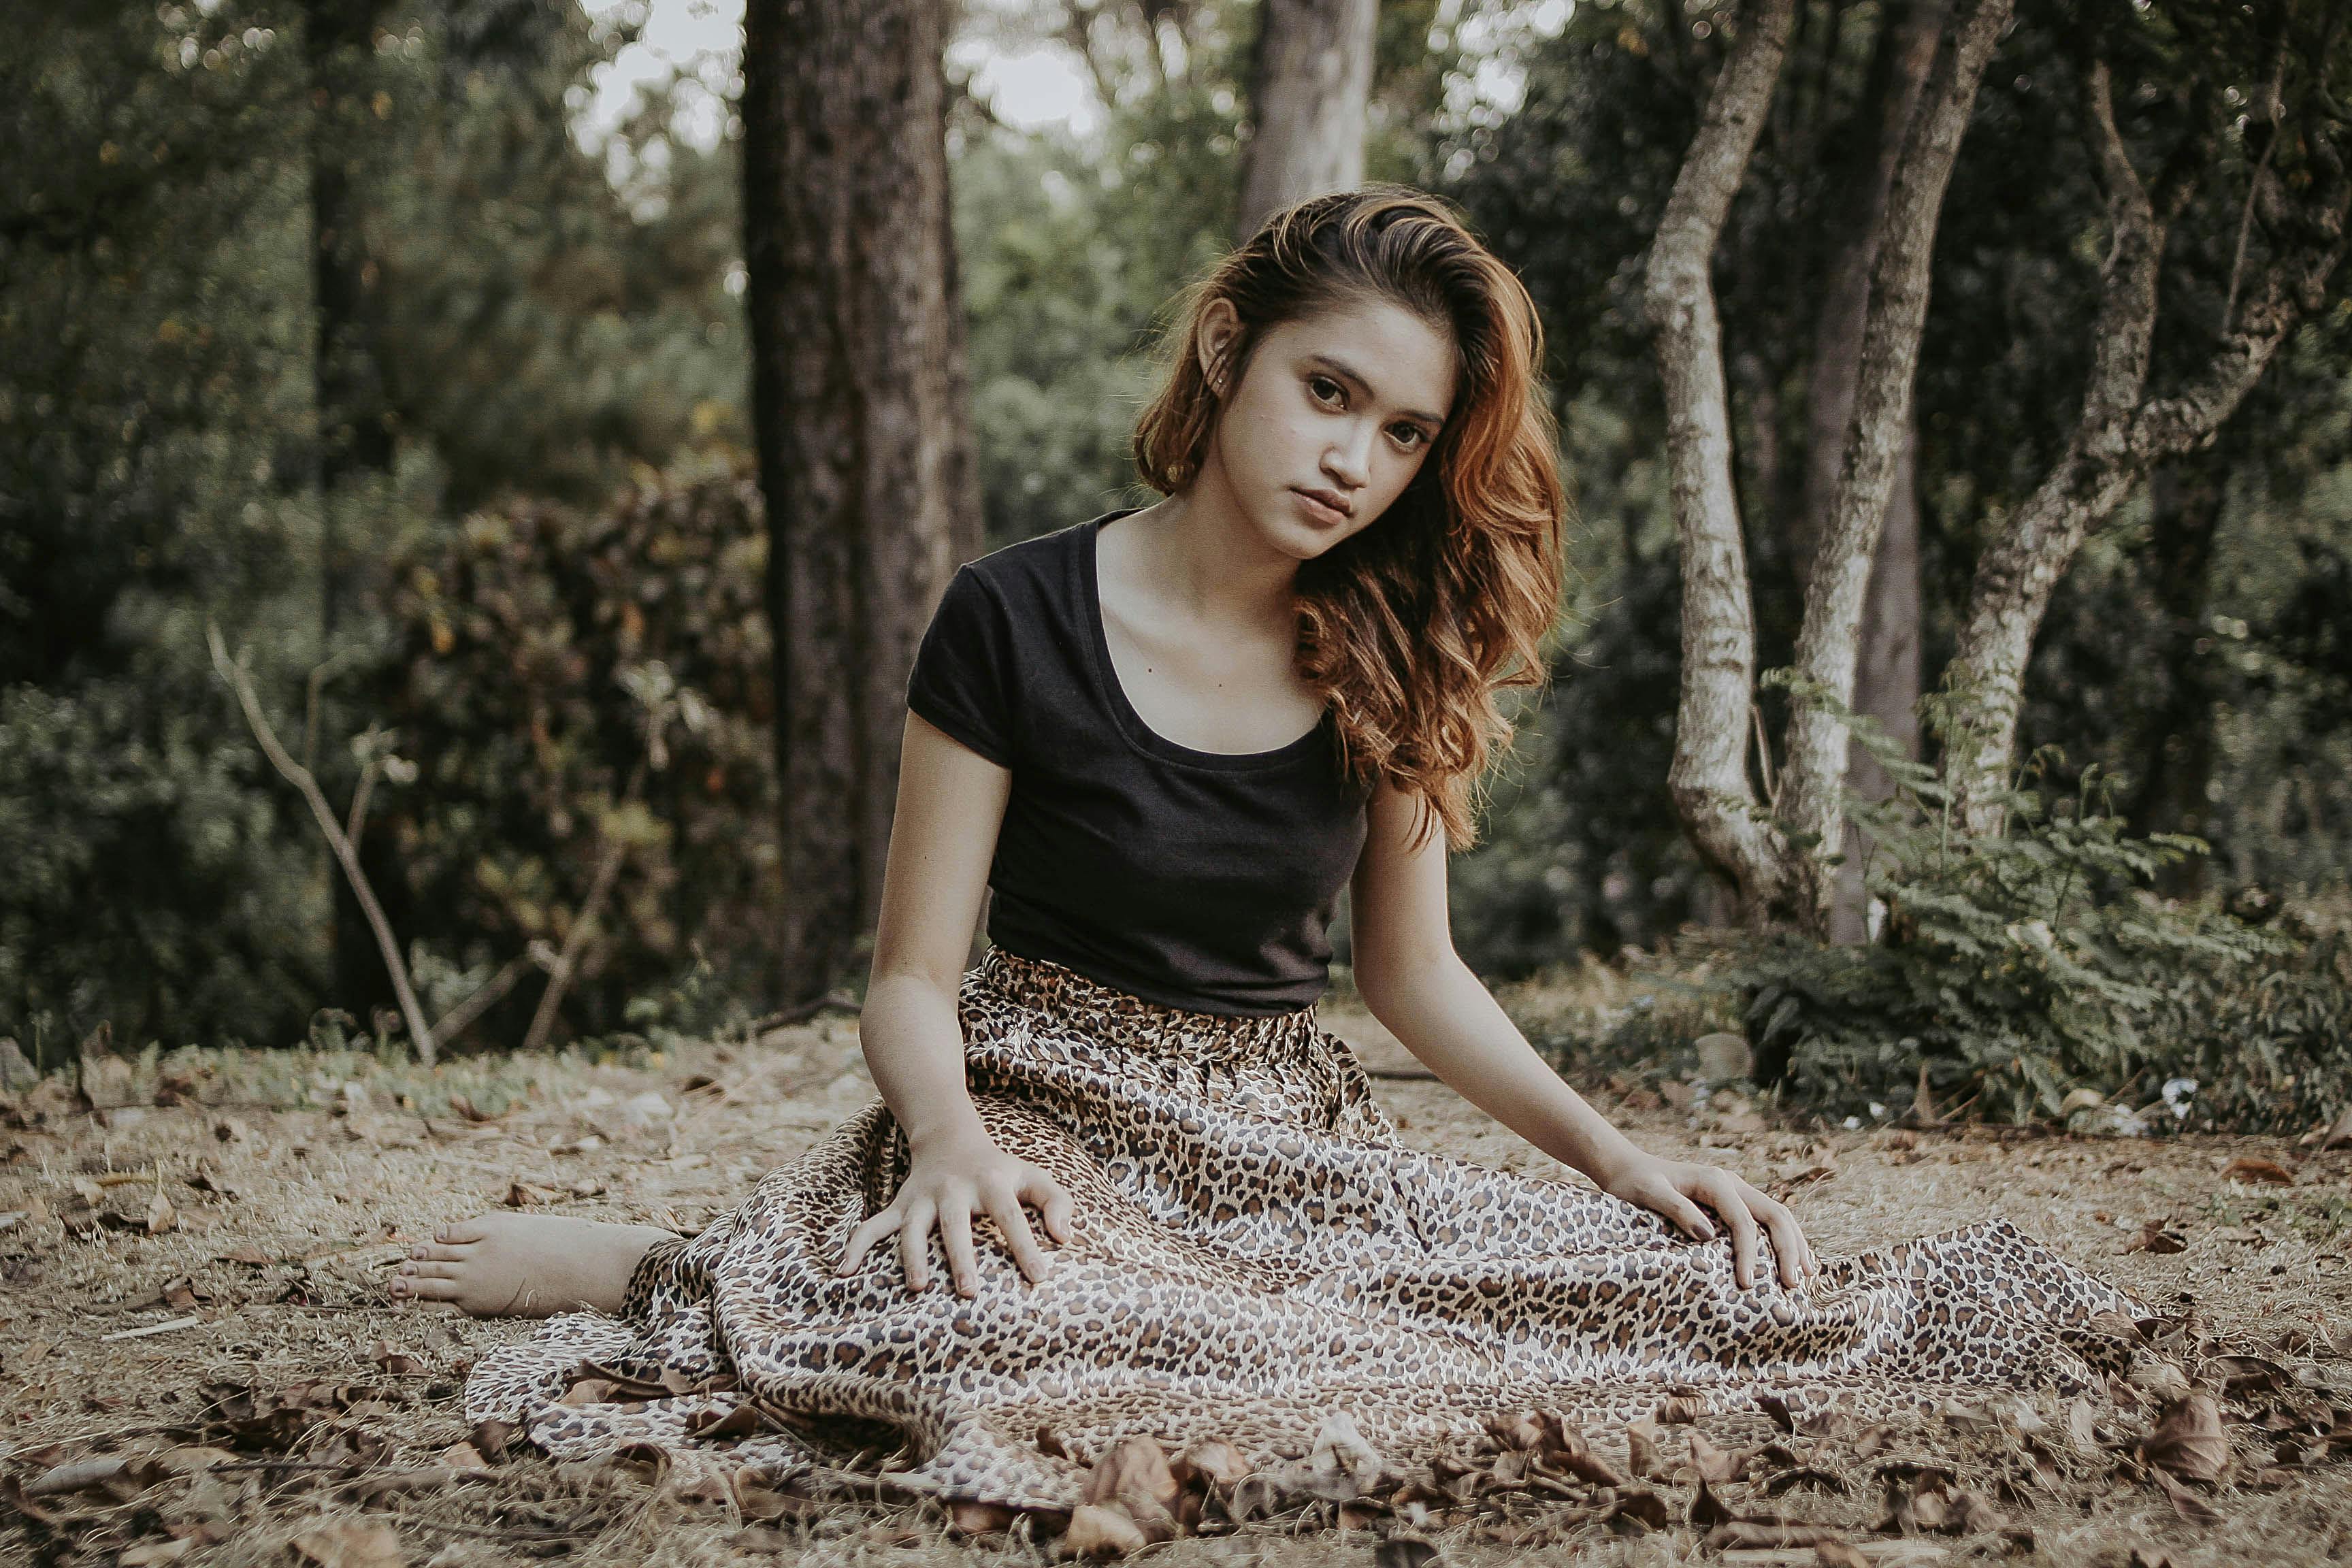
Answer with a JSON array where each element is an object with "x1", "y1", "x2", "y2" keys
[{"x1": 1945, "y1": 50, "x2": 2352, "y2": 832}]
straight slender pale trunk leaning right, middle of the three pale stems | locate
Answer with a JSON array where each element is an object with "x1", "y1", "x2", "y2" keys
[{"x1": 1780, "y1": 0, "x2": 2013, "y2": 936}]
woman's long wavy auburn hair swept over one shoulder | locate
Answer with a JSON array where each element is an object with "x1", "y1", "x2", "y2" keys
[{"x1": 1136, "y1": 186, "x2": 1567, "y2": 865}]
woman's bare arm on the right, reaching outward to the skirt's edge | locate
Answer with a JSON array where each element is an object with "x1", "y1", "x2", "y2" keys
[{"x1": 1350, "y1": 783, "x2": 1814, "y2": 1288}]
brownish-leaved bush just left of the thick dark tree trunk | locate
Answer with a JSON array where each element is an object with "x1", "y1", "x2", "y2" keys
[{"x1": 365, "y1": 453, "x2": 779, "y2": 1039}]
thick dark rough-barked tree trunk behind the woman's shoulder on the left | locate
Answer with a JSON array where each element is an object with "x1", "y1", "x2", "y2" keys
[{"x1": 743, "y1": 0, "x2": 976, "y2": 1006}]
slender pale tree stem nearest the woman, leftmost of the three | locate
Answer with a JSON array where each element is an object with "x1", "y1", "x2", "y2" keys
[{"x1": 1644, "y1": 0, "x2": 1795, "y2": 921}]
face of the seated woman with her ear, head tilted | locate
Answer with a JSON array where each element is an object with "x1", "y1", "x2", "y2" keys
[{"x1": 1202, "y1": 299, "x2": 1456, "y2": 559}]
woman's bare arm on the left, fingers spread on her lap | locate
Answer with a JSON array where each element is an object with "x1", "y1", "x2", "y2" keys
[{"x1": 840, "y1": 713, "x2": 1070, "y2": 1295}]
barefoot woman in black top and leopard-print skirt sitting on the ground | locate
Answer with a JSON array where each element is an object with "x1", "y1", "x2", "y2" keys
[{"x1": 395, "y1": 188, "x2": 2129, "y2": 1507}]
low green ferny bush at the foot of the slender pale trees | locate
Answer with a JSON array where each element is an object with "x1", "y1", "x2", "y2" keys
[{"x1": 1719, "y1": 738, "x2": 2352, "y2": 1126}]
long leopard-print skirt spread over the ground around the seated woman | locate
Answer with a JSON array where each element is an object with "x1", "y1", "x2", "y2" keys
[{"x1": 466, "y1": 950, "x2": 2145, "y2": 1507}]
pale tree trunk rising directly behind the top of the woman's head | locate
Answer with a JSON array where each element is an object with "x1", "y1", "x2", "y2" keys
[{"x1": 1235, "y1": 0, "x2": 1381, "y2": 240}]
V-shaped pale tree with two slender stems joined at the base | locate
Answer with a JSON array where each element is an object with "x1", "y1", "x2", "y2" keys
[{"x1": 1646, "y1": 0, "x2": 2011, "y2": 933}]
